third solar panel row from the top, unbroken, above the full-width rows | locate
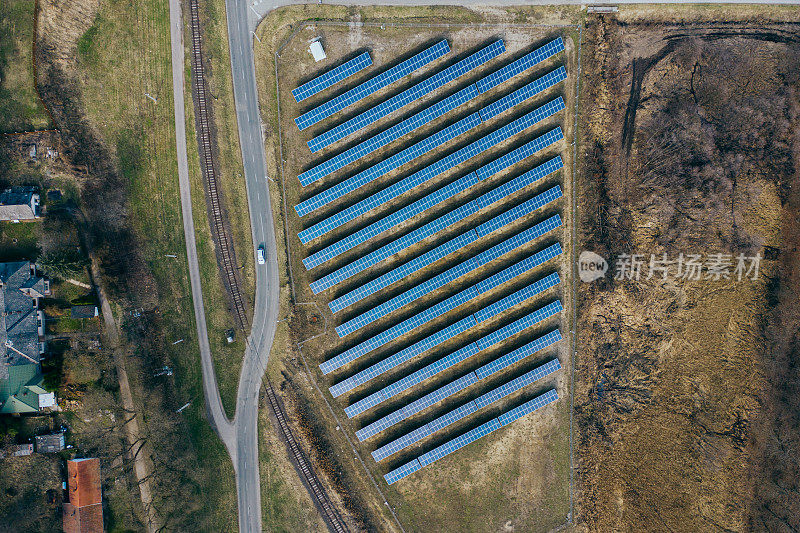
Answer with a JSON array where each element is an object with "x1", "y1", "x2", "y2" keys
[{"x1": 308, "y1": 40, "x2": 506, "y2": 152}]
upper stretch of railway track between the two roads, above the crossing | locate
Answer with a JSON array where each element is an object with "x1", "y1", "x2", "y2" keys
[{"x1": 189, "y1": 0, "x2": 247, "y2": 329}]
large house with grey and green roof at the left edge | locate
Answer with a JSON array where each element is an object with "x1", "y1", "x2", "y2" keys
[{"x1": 0, "y1": 261, "x2": 55, "y2": 414}]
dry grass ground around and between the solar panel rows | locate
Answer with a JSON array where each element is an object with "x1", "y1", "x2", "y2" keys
[{"x1": 255, "y1": 6, "x2": 579, "y2": 531}]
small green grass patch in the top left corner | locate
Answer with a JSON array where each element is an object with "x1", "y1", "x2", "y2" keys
[{"x1": 0, "y1": 0, "x2": 49, "y2": 133}]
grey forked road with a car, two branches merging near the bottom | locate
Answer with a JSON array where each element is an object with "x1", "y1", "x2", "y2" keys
[{"x1": 170, "y1": 0, "x2": 798, "y2": 533}]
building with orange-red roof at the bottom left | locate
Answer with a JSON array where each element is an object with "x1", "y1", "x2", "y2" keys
[{"x1": 62, "y1": 458, "x2": 103, "y2": 533}]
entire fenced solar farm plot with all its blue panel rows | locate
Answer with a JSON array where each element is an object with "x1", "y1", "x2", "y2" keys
[{"x1": 260, "y1": 17, "x2": 577, "y2": 531}]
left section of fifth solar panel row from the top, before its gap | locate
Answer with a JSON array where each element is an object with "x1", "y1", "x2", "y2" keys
[{"x1": 295, "y1": 113, "x2": 481, "y2": 217}]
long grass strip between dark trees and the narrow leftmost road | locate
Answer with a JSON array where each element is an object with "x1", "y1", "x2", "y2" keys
[{"x1": 34, "y1": 0, "x2": 236, "y2": 530}]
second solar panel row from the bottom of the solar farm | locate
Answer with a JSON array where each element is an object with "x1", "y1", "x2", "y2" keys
[{"x1": 372, "y1": 359, "x2": 561, "y2": 462}]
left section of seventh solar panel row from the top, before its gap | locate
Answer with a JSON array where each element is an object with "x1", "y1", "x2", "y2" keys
[{"x1": 303, "y1": 172, "x2": 478, "y2": 270}]
